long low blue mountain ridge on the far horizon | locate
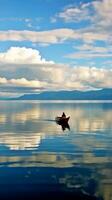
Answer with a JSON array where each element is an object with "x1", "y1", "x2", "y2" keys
[{"x1": 11, "y1": 89, "x2": 112, "y2": 100}]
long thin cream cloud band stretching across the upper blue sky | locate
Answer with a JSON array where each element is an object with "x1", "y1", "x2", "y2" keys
[{"x1": 0, "y1": 28, "x2": 109, "y2": 46}]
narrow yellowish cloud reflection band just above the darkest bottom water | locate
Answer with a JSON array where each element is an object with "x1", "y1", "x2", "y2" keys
[{"x1": 0, "y1": 151, "x2": 112, "y2": 168}]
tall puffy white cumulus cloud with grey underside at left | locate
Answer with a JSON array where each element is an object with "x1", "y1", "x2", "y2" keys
[{"x1": 0, "y1": 47, "x2": 67, "y2": 82}]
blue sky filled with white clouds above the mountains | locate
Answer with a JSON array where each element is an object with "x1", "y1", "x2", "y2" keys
[{"x1": 0, "y1": 0, "x2": 112, "y2": 97}]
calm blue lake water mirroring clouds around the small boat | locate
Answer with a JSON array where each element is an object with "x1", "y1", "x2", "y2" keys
[{"x1": 0, "y1": 101, "x2": 112, "y2": 200}]
